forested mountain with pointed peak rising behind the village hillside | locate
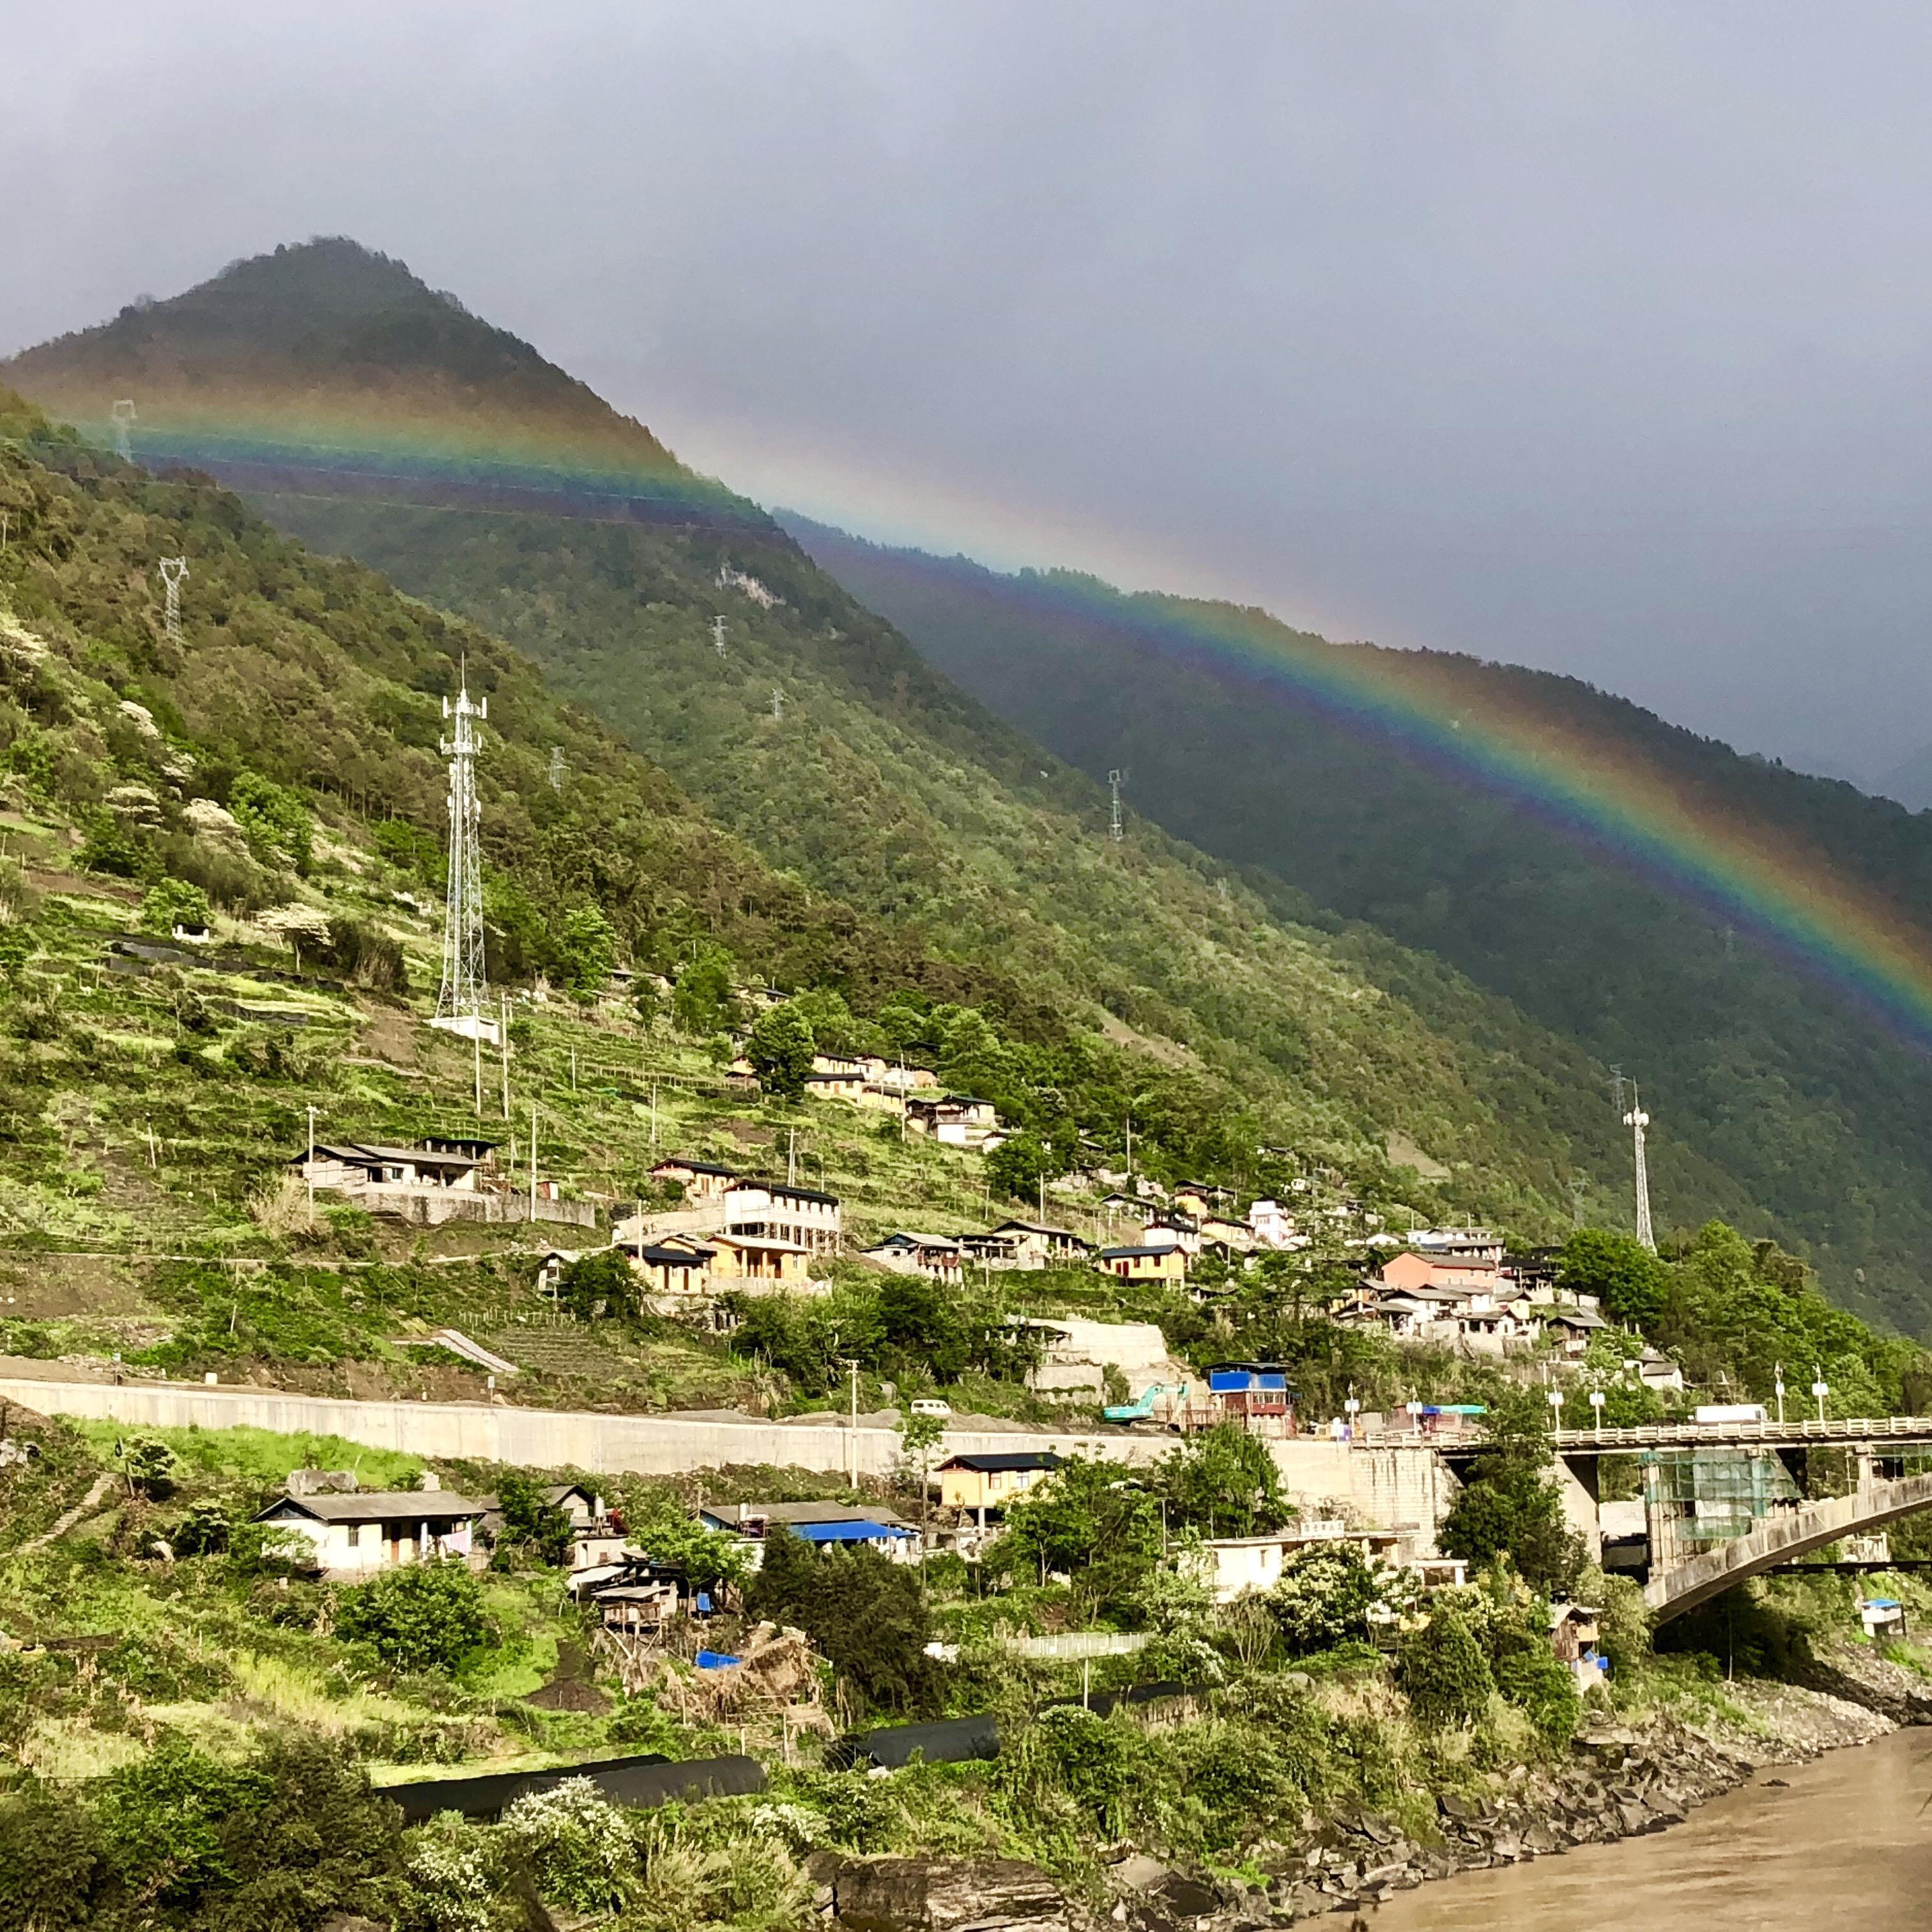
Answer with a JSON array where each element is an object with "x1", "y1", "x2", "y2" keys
[{"x1": 0, "y1": 243, "x2": 1839, "y2": 1267}]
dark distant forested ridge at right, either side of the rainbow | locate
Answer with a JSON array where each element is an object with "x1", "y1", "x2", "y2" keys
[{"x1": 776, "y1": 521, "x2": 1932, "y2": 1330}]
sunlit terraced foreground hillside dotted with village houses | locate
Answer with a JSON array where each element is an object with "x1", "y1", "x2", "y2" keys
[{"x1": 0, "y1": 380, "x2": 1932, "y2": 1932}]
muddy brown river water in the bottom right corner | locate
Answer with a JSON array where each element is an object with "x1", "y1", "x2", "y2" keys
[{"x1": 1370, "y1": 1729, "x2": 1932, "y2": 1932}]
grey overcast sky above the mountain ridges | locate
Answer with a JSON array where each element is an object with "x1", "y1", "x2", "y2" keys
[{"x1": 11, "y1": 0, "x2": 1932, "y2": 773}]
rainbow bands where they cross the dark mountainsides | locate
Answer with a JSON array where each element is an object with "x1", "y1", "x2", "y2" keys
[{"x1": 83, "y1": 396, "x2": 1932, "y2": 1049}]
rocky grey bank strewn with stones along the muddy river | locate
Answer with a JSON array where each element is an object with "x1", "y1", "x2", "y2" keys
[{"x1": 813, "y1": 1646, "x2": 1932, "y2": 1932}]
